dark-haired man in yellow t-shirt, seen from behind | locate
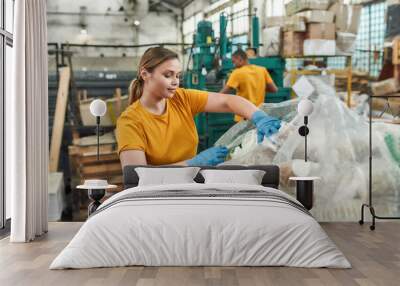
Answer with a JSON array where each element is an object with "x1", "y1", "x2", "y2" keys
[{"x1": 220, "y1": 49, "x2": 278, "y2": 122}]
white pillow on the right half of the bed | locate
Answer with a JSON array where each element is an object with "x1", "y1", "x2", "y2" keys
[{"x1": 200, "y1": 170, "x2": 265, "y2": 185}]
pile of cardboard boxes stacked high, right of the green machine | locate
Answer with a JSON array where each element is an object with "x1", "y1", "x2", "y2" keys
[{"x1": 264, "y1": 0, "x2": 361, "y2": 57}]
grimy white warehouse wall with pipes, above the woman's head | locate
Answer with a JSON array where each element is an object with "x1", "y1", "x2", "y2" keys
[{"x1": 47, "y1": 0, "x2": 181, "y2": 56}]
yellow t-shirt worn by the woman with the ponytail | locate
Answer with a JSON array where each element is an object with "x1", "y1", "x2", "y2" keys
[{"x1": 116, "y1": 88, "x2": 208, "y2": 165}]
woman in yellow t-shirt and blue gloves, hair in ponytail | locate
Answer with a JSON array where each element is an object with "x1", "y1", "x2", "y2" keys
[{"x1": 116, "y1": 47, "x2": 280, "y2": 167}]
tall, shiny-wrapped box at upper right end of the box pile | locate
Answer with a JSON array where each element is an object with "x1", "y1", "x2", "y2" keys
[{"x1": 329, "y1": 3, "x2": 362, "y2": 34}]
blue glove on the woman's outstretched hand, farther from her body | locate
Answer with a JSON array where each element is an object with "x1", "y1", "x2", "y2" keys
[{"x1": 251, "y1": 110, "x2": 281, "y2": 144}]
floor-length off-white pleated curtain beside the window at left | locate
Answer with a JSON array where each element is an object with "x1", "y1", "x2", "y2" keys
[{"x1": 5, "y1": 0, "x2": 49, "y2": 242}]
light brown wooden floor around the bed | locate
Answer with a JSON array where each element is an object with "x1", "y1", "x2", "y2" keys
[{"x1": 0, "y1": 221, "x2": 400, "y2": 286}]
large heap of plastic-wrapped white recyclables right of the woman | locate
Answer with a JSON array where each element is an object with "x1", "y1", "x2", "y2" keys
[{"x1": 217, "y1": 76, "x2": 400, "y2": 220}]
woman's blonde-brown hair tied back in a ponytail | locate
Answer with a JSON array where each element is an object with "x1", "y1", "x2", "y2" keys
[{"x1": 129, "y1": 47, "x2": 178, "y2": 104}]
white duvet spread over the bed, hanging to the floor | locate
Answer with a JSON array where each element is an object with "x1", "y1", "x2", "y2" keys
[{"x1": 50, "y1": 183, "x2": 351, "y2": 269}]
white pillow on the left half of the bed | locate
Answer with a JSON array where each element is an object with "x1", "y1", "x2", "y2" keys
[{"x1": 135, "y1": 167, "x2": 200, "y2": 186}]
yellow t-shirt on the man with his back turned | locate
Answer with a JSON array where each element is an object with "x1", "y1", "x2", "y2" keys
[{"x1": 226, "y1": 65, "x2": 273, "y2": 121}]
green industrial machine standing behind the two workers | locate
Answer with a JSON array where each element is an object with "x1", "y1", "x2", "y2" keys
[{"x1": 184, "y1": 13, "x2": 290, "y2": 151}]
